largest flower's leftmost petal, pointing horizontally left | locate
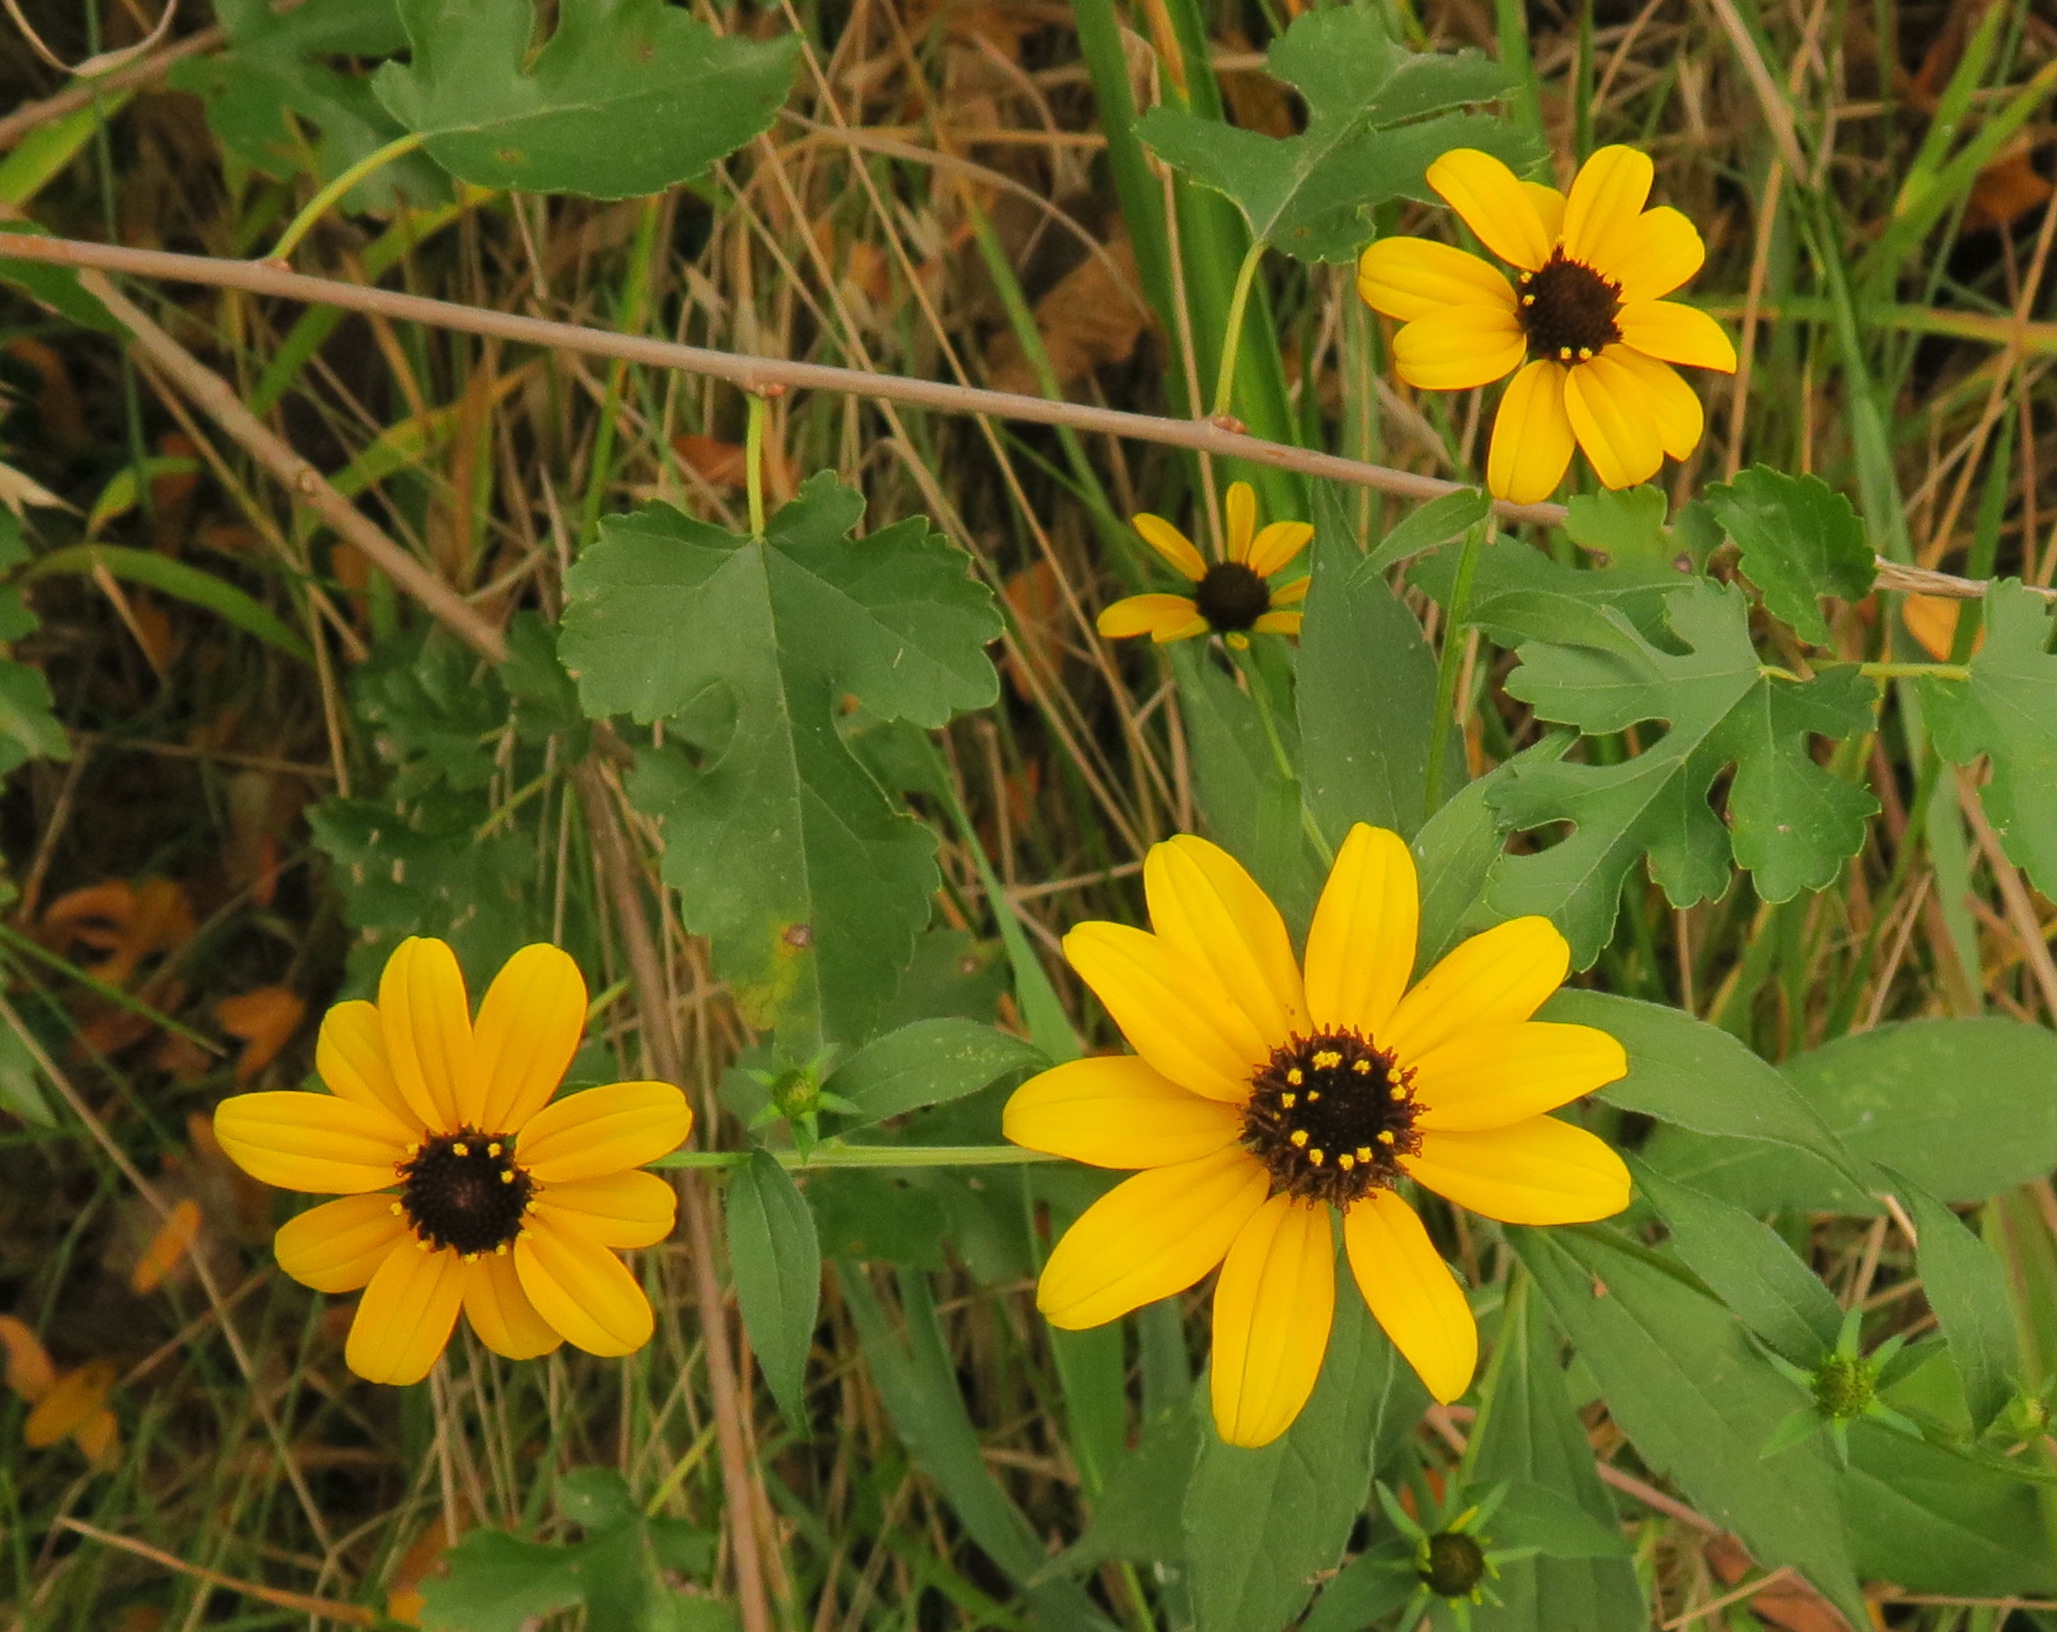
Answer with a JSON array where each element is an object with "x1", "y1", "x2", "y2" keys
[{"x1": 1000, "y1": 1054, "x2": 1242, "y2": 1167}]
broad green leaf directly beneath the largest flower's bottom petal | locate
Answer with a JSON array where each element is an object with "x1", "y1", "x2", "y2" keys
[{"x1": 1185, "y1": 1284, "x2": 1426, "y2": 1632}]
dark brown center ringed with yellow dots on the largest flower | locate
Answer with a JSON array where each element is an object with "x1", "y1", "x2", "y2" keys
[{"x1": 1242, "y1": 1031, "x2": 1421, "y2": 1208}]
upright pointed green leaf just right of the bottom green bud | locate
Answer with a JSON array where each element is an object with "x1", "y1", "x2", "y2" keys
[{"x1": 1471, "y1": 1274, "x2": 1650, "y2": 1632}]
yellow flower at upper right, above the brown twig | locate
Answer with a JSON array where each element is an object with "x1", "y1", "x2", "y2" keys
[{"x1": 1358, "y1": 146, "x2": 1736, "y2": 504}]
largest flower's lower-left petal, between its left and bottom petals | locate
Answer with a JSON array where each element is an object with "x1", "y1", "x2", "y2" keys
[{"x1": 1035, "y1": 1146, "x2": 1271, "y2": 1332}]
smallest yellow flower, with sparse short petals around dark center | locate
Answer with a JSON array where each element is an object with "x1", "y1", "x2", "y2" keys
[{"x1": 1100, "y1": 482, "x2": 1314, "y2": 650}]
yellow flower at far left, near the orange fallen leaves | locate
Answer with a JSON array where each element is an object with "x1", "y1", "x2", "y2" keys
[{"x1": 214, "y1": 938, "x2": 693, "y2": 1383}]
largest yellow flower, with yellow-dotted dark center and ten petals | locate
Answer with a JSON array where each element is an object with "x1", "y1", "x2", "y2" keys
[{"x1": 1006, "y1": 823, "x2": 1629, "y2": 1445}]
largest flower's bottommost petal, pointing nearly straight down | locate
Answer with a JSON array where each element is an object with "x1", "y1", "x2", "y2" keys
[{"x1": 1210, "y1": 1196, "x2": 1335, "y2": 1447}]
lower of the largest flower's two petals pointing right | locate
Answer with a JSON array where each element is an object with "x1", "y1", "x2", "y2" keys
[{"x1": 1401, "y1": 1115, "x2": 1629, "y2": 1225}]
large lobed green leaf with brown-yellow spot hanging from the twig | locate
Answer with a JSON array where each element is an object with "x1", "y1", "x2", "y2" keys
[{"x1": 560, "y1": 473, "x2": 1000, "y2": 1058}]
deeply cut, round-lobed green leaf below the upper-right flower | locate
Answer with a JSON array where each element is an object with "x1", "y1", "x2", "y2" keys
[{"x1": 1493, "y1": 582, "x2": 1878, "y2": 967}]
